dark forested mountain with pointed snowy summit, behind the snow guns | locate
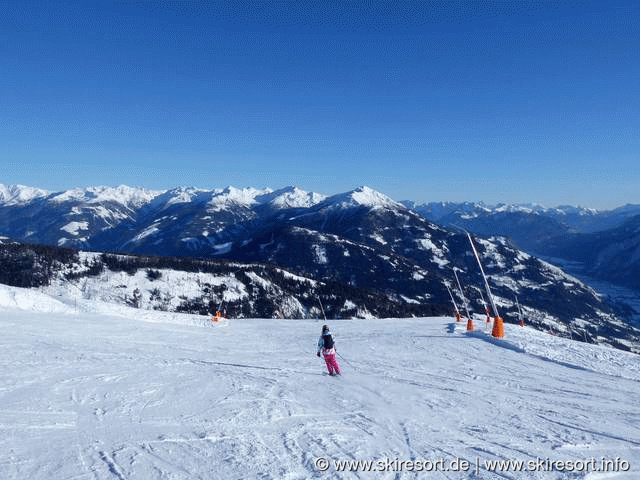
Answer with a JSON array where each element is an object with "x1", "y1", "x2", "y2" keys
[{"x1": 225, "y1": 199, "x2": 640, "y2": 348}]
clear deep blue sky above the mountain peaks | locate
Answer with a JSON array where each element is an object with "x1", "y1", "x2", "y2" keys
[{"x1": 0, "y1": 0, "x2": 640, "y2": 208}]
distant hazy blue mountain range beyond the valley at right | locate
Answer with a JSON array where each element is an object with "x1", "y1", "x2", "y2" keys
[{"x1": 403, "y1": 202, "x2": 640, "y2": 290}]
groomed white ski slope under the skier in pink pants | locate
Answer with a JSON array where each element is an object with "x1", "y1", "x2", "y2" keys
[{"x1": 0, "y1": 286, "x2": 640, "y2": 480}]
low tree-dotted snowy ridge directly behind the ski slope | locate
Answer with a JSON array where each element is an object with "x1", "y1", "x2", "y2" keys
[{"x1": 0, "y1": 242, "x2": 440, "y2": 318}]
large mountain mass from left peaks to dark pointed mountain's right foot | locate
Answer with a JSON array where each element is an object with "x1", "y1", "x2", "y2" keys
[{"x1": 0, "y1": 182, "x2": 640, "y2": 348}]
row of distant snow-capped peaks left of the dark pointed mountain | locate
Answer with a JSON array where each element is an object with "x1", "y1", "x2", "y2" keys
[{"x1": 0, "y1": 184, "x2": 325, "y2": 254}]
